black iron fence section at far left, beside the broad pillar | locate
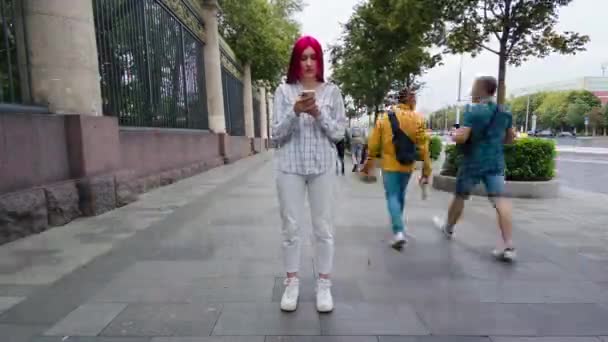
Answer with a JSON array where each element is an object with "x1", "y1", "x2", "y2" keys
[{"x1": 0, "y1": 0, "x2": 30, "y2": 104}]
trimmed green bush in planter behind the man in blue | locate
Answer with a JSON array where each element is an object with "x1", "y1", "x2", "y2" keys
[{"x1": 441, "y1": 138, "x2": 556, "y2": 181}]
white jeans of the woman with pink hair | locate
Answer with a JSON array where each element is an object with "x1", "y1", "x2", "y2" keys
[{"x1": 277, "y1": 170, "x2": 336, "y2": 274}]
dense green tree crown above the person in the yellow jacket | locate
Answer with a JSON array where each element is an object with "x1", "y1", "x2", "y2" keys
[{"x1": 331, "y1": 0, "x2": 441, "y2": 115}]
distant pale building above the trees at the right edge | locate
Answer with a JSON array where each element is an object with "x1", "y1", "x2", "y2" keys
[{"x1": 509, "y1": 76, "x2": 608, "y2": 105}]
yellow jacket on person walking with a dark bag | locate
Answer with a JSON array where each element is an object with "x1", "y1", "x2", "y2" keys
[{"x1": 368, "y1": 104, "x2": 432, "y2": 176}]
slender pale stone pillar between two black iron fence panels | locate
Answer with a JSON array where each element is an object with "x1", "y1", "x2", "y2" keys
[{"x1": 203, "y1": 0, "x2": 226, "y2": 134}]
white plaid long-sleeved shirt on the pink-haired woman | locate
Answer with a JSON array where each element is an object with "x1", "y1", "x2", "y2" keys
[{"x1": 271, "y1": 83, "x2": 346, "y2": 175}]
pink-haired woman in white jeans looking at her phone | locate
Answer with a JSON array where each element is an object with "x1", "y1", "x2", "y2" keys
[{"x1": 272, "y1": 36, "x2": 346, "y2": 312}]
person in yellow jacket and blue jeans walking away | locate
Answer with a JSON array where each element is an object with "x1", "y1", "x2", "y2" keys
[{"x1": 364, "y1": 90, "x2": 432, "y2": 250}]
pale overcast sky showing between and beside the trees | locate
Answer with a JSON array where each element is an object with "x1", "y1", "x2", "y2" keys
[{"x1": 299, "y1": 0, "x2": 608, "y2": 112}]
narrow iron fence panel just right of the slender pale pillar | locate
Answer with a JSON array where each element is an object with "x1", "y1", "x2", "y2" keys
[{"x1": 221, "y1": 49, "x2": 245, "y2": 136}]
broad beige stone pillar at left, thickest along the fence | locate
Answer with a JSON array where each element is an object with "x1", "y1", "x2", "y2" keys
[{"x1": 23, "y1": 0, "x2": 103, "y2": 115}]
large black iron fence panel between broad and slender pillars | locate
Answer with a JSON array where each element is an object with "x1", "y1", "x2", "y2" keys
[{"x1": 94, "y1": 0, "x2": 208, "y2": 129}]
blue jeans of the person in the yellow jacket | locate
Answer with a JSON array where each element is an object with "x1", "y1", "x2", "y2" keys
[{"x1": 382, "y1": 171, "x2": 412, "y2": 234}]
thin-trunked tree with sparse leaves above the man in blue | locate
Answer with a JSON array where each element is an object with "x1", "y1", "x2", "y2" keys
[{"x1": 445, "y1": 0, "x2": 589, "y2": 104}]
